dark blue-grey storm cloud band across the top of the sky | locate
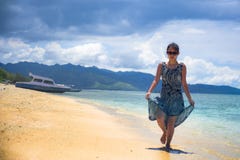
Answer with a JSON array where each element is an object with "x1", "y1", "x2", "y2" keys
[{"x1": 0, "y1": 0, "x2": 240, "y2": 40}]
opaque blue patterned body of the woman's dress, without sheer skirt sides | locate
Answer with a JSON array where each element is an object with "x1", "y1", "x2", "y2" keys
[{"x1": 160, "y1": 62, "x2": 184, "y2": 116}]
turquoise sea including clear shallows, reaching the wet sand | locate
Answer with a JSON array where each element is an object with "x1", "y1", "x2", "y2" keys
[{"x1": 64, "y1": 90, "x2": 240, "y2": 159}]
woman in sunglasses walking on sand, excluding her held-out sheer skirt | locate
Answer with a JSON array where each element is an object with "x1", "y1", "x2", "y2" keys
[{"x1": 145, "y1": 43, "x2": 194, "y2": 151}]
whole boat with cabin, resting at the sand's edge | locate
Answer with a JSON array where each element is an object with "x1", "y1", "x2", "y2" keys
[{"x1": 15, "y1": 73, "x2": 81, "y2": 93}]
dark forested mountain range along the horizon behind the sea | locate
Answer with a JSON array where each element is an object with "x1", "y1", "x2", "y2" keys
[{"x1": 0, "y1": 62, "x2": 240, "y2": 94}]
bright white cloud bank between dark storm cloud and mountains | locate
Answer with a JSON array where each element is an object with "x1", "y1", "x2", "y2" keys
[{"x1": 0, "y1": 20, "x2": 240, "y2": 87}]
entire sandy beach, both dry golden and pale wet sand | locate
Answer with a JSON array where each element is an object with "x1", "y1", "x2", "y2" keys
[{"x1": 0, "y1": 84, "x2": 240, "y2": 160}]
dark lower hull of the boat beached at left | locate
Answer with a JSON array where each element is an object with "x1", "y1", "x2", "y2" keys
[{"x1": 15, "y1": 82, "x2": 71, "y2": 93}]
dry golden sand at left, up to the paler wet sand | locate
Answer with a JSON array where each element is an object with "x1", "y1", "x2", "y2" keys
[{"x1": 0, "y1": 84, "x2": 172, "y2": 160}]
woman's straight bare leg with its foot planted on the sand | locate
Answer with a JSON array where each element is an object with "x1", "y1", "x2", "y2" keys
[{"x1": 166, "y1": 116, "x2": 177, "y2": 150}]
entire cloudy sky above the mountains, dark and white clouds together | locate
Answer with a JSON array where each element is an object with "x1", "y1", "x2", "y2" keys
[{"x1": 0, "y1": 0, "x2": 240, "y2": 88}]
